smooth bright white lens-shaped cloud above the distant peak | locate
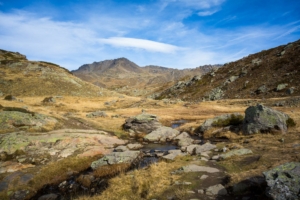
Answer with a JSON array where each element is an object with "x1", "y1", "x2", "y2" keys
[{"x1": 98, "y1": 37, "x2": 180, "y2": 53}]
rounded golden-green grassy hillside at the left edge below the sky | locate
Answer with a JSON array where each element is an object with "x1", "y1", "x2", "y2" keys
[{"x1": 0, "y1": 50, "x2": 112, "y2": 96}]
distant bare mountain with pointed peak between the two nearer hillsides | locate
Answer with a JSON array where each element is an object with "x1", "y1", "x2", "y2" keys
[{"x1": 72, "y1": 58, "x2": 218, "y2": 96}]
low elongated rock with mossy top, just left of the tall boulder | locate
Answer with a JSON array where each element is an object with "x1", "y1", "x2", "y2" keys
[{"x1": 196, "y1": 113, "x2": 244, "y2": 133}]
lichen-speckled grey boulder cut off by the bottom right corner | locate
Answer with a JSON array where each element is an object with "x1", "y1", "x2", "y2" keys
[{"x1": 263, "y1": 162, "x2": 300, "y2": 200}]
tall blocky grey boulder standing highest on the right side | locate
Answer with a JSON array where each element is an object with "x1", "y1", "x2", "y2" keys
[{"x1": 243, "y1": 104, "x2": 289, "y2": 134}]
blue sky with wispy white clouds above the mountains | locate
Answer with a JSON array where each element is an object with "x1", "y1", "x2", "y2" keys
[{"x1": 0, "y1": 0, "x2": 300, "y2": 70}]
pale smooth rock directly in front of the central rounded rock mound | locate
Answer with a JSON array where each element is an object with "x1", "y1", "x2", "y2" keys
[{"x1": 144, "y1": 126, "x2": 180, "y2": 142}]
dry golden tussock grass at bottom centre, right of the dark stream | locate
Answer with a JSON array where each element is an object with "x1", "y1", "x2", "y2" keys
[{"x1": 79, "y1": 162, "x2": 181, "y2": 200}]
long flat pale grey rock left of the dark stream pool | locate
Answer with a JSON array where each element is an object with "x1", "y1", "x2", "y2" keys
[{"x1": 91, "y1": 151, "x2": 143, "y2": 170}]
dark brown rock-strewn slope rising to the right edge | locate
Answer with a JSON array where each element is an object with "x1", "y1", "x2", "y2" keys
[{"x1": 157, "y1": 40, "x2": 300, "y2": 101}]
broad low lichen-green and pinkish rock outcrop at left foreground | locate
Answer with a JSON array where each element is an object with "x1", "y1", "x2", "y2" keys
[{"x1": 0, "y1": 129, "x2": 125, "y2": 171}]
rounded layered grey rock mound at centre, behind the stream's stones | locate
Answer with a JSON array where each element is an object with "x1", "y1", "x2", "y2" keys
[{"x1": 123, "y1": 113, "x2": 162, "y2": 134}]
